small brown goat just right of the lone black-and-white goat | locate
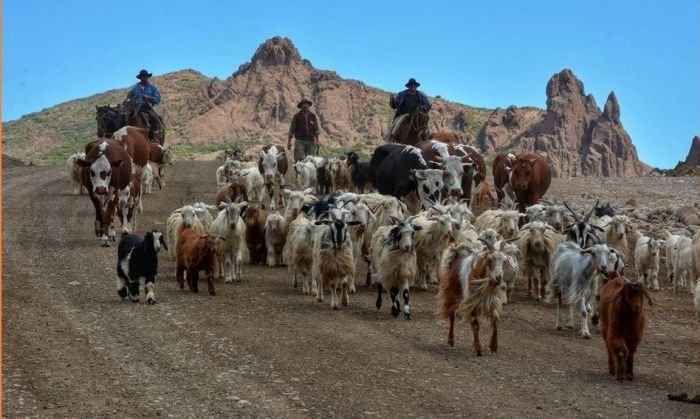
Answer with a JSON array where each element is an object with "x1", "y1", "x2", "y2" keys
[{"x1": 175, "y1": 225, "x2": 219, "y2": 295}]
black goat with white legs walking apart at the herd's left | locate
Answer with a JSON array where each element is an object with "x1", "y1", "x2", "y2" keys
[{"x1": 117, "y1": 230, "x2": 168, "y2": 304}]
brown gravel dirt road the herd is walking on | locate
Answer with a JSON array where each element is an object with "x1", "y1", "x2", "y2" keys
[{"x1": 2, "y1": 163, "x2": 700, "y2": 418}]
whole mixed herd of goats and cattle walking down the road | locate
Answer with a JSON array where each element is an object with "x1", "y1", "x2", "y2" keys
[{"x1": 67, "y1": 127, "x2": 700, "y2": 380}]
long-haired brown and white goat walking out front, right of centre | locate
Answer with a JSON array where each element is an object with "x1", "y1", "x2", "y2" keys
[{"x1": 438, "y1": 244, "x2": 507, "y2": 356}]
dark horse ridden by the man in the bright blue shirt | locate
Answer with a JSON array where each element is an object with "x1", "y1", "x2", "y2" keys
[{"x1": 95, "y1": 98, "x2": 165, "y2": 145}]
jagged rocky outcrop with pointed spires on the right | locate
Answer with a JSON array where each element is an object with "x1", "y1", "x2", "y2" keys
[{"x1": 479, "y1": 69, "x2": 650, "y2": 176}]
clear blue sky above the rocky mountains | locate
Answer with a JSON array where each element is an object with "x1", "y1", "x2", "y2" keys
[{"x1": 2, "y1": 0, "x2": 700, "y2": 167}]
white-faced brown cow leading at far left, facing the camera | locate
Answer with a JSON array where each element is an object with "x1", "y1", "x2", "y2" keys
[{"x1": 78, "y1": 139, "x2": 132, "y2": 246}]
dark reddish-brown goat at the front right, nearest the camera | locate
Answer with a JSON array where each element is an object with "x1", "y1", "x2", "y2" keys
[{"x1": 599, "y1": 273, "x2": 652, "y2": 381}]
